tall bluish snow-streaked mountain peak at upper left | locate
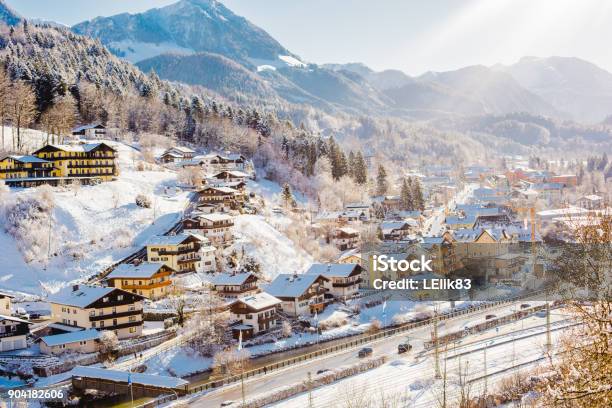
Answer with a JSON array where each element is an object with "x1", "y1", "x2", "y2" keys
[{"x1": 72, "y1": 0, "x2": 297, "y2": 65}]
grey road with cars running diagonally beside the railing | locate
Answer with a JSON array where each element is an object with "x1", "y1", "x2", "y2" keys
[{"x1": 190, "y1": 302, "x2": 556, "y2": 408}]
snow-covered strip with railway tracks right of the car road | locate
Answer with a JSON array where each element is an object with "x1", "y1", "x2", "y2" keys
[{"x1": 266, "y1": 310, "x2": 571, "y2": 408}]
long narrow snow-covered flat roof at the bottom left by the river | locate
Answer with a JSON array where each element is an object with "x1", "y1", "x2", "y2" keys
[{"x1": 70, "y1": 366, "x2": 189, "y2": 388}]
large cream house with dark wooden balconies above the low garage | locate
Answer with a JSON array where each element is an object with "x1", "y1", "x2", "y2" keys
[{"x1": 47, "y1": 285, "x2": 144, "y2": 339}]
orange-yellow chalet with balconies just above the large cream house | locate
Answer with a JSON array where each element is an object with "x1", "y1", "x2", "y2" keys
[{"x1": 106, "y1": 262, "x2": 174, "y2": 300}]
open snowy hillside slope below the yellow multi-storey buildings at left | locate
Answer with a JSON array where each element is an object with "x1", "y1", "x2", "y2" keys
[{"x1": 0, "y1": 131, "x2": 188, "y2": 294}]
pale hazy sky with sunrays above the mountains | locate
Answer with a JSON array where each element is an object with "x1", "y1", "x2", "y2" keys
[{"x1": 5, "y1": 0, "x2": 612, "y2": 74}]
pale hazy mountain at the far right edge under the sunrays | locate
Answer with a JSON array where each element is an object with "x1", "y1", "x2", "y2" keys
[{"x1": 494, "y1": 57, "x2": 612, "y2": 122}]
